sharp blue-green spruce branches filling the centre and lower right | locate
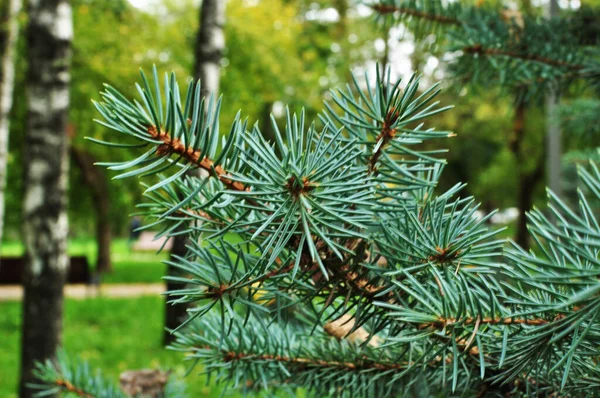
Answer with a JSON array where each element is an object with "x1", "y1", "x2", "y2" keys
[{"x1": 30, "y1": 59, "x2": 600, "y2": 396}]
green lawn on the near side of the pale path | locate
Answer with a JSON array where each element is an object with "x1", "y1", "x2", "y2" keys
[{"x1": 0, "y1": 297, "x2": 227, "y2": 398}]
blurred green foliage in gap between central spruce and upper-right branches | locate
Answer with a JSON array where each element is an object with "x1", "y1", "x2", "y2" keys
[{"x1": 434, "y1": 89, "x2": 516, "y2": 207}]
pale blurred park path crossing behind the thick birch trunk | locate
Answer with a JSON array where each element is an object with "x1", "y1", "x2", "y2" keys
[{"x1": 0, "y1": 283, "x2": 165, "y2": 301}]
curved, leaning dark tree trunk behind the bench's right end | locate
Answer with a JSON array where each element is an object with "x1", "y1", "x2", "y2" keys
[{"x1": 70, "y1": 147, "x2": 112, "y2": 273}]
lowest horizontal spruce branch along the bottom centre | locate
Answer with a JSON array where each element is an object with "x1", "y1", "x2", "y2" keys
[{"x1": 174, "y1": 314, "x2": 424, "y2": 397}]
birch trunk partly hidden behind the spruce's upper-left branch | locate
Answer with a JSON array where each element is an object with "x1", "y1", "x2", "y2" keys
[{"x1": 163, "y1": 0, "x2": 225, "y2": 345}]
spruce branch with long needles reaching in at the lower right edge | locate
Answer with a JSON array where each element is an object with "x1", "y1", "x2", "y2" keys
[{"x1": 505, "y1": 163, "x2": 600, "y2": 394}]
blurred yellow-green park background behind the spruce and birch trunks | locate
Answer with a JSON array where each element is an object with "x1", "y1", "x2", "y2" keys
[{"x1": 0, "y1": 0, "x2": 600, "y2": 397}]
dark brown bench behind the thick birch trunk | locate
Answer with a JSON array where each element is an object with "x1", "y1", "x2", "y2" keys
[{"x1": 0, "y1": 256, "x2": 92, "y2": 285}]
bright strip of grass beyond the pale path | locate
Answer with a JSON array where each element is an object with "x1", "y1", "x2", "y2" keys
[{"x1": 2, "y1": 239, "x2": 168, "y2": 283}]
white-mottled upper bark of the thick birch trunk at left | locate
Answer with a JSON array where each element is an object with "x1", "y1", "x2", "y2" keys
[{"x1": 23, "y1": 0, "x2": 73, "y2": 279}]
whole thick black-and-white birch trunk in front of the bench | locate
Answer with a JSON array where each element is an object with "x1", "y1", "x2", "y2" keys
[{"x1": 20, "y1": 0, "x2": 73, "y2": 398}]
